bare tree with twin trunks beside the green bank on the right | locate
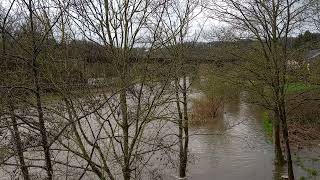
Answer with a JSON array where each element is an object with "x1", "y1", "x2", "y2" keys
[{"x1": 211, "y1": 0, "x2": 306, "y2": 179}]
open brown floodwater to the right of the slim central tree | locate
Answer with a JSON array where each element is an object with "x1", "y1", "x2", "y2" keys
[{"x1": 176, "y1": 93, "x2": 320, "y2": 180}]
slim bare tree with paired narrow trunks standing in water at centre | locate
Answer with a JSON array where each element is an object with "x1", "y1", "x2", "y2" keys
[{"x1": 162, "y1": 0, "x2": 201, "y2": 178}]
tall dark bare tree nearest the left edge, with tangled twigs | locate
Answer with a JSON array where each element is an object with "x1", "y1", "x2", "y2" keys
[{"x1": 1, "y1": 0, "x2": 68, "y2": 179}]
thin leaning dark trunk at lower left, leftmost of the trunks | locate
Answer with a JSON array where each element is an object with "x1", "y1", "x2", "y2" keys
[{"x1": 9, "y1": 102, "x2": 30, "y2": 180}]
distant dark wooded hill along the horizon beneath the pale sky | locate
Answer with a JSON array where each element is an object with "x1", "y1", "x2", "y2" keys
[{"x1": 1, "y1": 31, "x2": 320, "y2": 70}]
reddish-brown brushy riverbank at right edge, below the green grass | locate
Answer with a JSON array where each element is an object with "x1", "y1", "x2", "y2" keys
[{"x1": 288, "y1": 88, "x2": 320, "y2": 149}]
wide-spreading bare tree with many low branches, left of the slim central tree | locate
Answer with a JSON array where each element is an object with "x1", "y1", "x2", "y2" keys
[{"x1": 47, "y1": 0, "x2": 180, "y2": 179}]
